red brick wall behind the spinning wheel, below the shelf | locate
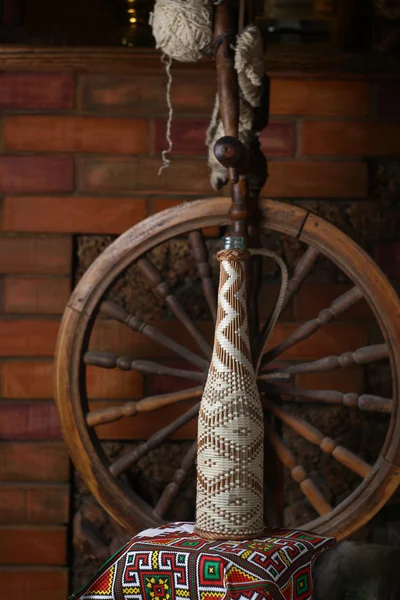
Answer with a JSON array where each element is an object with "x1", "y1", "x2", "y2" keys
[{"x1": 0, "y1": 71, "x2": 400, "y2": 600}]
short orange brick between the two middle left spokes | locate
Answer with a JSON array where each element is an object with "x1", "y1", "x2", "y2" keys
[{"x1": 86, "y1": 366, "x2": 143, "y2": 400}]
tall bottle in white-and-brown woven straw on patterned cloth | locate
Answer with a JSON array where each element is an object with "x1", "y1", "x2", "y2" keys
[{"x1": 196, "y1": 238, "x2": 264, "y2": 539}]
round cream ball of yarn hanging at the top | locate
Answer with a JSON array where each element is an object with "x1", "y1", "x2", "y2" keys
[{"x1": 150, "y1": 0, "x2": 213, "y2": 62}]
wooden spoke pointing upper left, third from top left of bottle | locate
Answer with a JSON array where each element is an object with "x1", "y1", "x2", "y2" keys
[{"x1": 101, "y1": 301, "x2": 208, "y2": 370}]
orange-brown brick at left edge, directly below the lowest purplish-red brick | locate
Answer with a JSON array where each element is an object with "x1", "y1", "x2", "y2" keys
[{"x1": 0, "y1": 442, "x2": 69, "y2": 482}]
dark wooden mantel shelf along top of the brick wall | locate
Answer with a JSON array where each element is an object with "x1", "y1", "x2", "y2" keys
[{"x1": 0, "y1": 45, "x2": 400, "y2": 78}]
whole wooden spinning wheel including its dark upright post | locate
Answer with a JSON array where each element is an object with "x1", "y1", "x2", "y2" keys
[{"x1": 55, "y1": 0, "x2": 400, "y2": 539}]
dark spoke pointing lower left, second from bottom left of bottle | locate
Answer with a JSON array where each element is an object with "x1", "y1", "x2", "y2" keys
[{"x1": 109, "y1": 402, "x2": 200, "y2": 477}]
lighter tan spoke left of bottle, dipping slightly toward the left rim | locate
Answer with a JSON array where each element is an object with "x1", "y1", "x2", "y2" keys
[{"x1": 86, "y1": 386, "x2": 203, "y2": 427}]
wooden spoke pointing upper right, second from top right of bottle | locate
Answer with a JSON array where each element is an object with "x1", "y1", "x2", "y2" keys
[{"x1": 261, "y1": 287, "x2": 363, "y2": 365}]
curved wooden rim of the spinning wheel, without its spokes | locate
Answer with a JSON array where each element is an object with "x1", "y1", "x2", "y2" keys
[{"x1": 55, "y1": 198, "x2": 400, "y2": 539}]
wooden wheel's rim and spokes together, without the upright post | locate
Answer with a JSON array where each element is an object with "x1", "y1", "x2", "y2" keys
[{"x1": 56, "y1": 198, "x2": 400, "y2": 539}]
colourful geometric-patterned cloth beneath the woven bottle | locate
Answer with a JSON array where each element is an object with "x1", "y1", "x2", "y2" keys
[{"x1": 70, "y1": 523, "x2": 334, "y2": 600}]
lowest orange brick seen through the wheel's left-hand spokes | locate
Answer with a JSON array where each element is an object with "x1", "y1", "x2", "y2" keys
[{"x1": 90, "y1": 402, "x2": 197, "y2": 440}]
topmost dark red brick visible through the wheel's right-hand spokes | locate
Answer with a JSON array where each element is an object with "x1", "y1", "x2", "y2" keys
[{"x1": 294, "y1": 283, "x2": 373, "y2": 320}]
